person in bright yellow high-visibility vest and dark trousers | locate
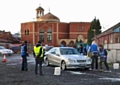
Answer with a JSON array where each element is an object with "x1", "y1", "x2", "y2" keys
[{"x1": 33, "y1": 41, "x2": 44, "y2": 75}]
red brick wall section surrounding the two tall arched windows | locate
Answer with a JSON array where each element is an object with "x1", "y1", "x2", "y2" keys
[{"x1": 35, "y1": 22, "x2": 57, "y2": 45}]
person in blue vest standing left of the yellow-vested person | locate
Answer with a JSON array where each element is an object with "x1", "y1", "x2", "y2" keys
[{"x1": 20, "y1": 41, "x2": 28, "y2": 71}]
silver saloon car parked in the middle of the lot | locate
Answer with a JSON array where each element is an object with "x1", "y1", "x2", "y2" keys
[{"x1": 44, "y1": 47, "x2": 92, "y2": 70}]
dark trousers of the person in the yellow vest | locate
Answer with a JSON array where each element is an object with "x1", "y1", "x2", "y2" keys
[{"x1": 35, "y1": 58, "x2": 43, "y2": 75}]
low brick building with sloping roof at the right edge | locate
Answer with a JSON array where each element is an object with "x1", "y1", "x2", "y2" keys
[{"x1": 97, "y1": 23, "x2": 120, "y2": 44}]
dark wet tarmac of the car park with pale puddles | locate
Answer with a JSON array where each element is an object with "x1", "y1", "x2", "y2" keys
[{"x1": 0, "y1": 54, "x2": 120, "y2": 85}]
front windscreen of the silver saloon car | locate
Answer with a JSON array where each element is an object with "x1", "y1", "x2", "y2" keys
[{"x1": 60, "y1": 48, "x2": 79, "y2": 55}]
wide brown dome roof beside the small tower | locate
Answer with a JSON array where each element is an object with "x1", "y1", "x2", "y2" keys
[{"x1": 40, "y1": 12, "x2": 60, "y2": 21}]
